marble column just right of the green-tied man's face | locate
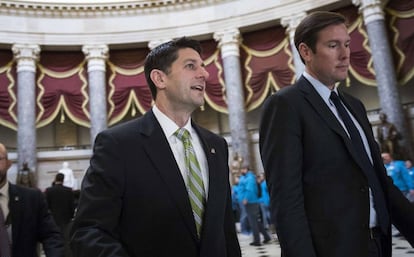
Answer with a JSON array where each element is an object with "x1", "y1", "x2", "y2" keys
[{"x1": 214, "y1": 29, "x2": 250, "y2": 166}]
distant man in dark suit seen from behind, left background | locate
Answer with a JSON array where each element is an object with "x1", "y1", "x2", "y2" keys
[{"x1": 45, "y1": 173, "x2": 75, "y2": 256}]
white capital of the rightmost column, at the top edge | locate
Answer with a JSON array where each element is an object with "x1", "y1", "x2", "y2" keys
[{"x1": 352, "y1": 0, "x2": 388, "y2": 25}]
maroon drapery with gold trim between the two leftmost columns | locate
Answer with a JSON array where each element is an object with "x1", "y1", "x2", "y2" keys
[{"x1": 36, "y1": 51, "x2": 89, "y2": 127}]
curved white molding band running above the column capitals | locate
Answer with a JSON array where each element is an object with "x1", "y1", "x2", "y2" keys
[{"x1": 0, "y1": 0, "x2": 350, "y2": 47}]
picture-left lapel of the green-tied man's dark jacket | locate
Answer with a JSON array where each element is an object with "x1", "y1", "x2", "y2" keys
[{"x1": 140, "y1": 111, "x2": 197, "y2": 238}]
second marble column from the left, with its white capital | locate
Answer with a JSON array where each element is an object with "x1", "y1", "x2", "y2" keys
[{"x1": 82, "y1": 45, "x2": 109, "y2": 146}]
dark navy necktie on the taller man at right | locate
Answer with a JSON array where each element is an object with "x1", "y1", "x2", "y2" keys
[{"x1": 329, "y1": 91, "x2": 389, "y2": 234}]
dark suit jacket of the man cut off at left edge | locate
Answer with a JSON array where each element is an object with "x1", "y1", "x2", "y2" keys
[{"x1": 8, "y1": 184, "x2": 63, "y2": 257}]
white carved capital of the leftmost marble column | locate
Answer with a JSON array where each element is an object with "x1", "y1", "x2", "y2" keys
[{"x1": 12, "y1": 44, "x2": 40, "y2": 72}]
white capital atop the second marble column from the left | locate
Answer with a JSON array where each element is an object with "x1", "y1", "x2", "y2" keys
[{"x1": 82, "y1": 45, "x2": 109, "y2": 72}]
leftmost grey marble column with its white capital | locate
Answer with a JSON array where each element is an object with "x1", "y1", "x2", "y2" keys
[{"x1": 12, "y1": 44, "x2": 40, "y2": 174}]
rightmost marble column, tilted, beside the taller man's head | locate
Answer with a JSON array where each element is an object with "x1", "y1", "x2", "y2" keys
[{"x1": 352, "y1": 0, "x2": 414, "y2": 158}]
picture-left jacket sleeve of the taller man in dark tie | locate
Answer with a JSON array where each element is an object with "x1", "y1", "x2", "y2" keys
[{"x1": 259, "y1": 95, "x2": 316, "y2": 257}]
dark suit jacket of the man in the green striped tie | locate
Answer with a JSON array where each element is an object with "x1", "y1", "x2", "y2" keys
[{"x1": 71, "y1": 111, "x2": 241, "y2": 257}]
